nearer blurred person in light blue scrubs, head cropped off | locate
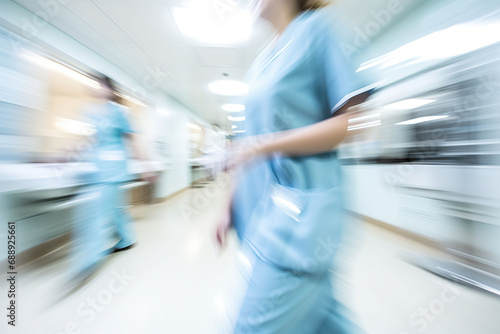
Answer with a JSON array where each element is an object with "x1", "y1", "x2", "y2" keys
[{"x1": 216, "y1": 0, "x2": 370, "y2": 334}]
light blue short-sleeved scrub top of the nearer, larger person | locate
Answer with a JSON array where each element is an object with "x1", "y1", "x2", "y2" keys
[{"x1": 233, "y1": 9, "x2": 370, "y2": 271}]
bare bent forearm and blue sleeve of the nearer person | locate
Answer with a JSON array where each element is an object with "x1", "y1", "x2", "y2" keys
[{"x1": 240, "y1": 19, "x2": 375, "y2": 160}]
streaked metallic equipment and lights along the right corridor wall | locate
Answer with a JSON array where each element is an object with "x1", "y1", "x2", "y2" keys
[{"x1": 340, "y1": 7, "x2": 500, "y2": 295}]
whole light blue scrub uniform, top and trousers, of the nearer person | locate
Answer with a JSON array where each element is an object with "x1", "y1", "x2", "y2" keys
[{"x1": 232, "y1": 9, "x2": 370, "y2": 334}]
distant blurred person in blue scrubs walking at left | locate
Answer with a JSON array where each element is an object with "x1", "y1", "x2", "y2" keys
[{"x1": 68, "y1": 77, "x2": 155, "y2": 279}]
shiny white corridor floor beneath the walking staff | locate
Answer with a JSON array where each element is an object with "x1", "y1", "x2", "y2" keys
[{"x1": 0, "y1": 180, "x2": 500, "y2": 334}]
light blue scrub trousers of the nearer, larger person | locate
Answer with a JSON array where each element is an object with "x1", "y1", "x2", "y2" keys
[{"x1": 234, "y1": 245, "x2": 363, "y2": 334}]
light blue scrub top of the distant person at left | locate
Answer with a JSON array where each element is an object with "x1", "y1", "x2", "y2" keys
[{"x1": 85, "y1": 102, "x2": 133, "y2": 183}]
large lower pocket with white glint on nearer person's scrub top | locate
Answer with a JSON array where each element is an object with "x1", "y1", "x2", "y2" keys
[{"x1": 249, "y1": 183, "x2": 342, "y2": 273}]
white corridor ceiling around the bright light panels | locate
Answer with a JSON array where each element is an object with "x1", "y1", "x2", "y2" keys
[{"x1": 15, "y1": 0, "x2": 411, "y2": 126}]
